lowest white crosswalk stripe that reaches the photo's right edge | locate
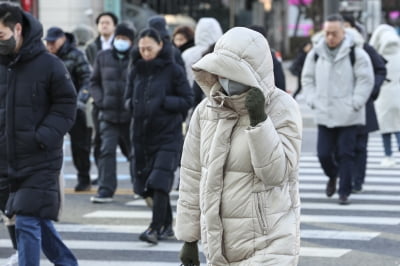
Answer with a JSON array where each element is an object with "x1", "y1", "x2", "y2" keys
[{"x1": 300, "y1": 215, "x2": 400, "y2": 225}]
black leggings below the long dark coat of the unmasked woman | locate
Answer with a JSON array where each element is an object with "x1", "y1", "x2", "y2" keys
[{"x1": 150, "y1": 190, "x2": 172, "y2": 231}]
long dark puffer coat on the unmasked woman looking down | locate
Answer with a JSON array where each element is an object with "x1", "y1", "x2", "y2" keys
[{"x1": 125, "y1": 41, "x2": 193, "y2": 196}]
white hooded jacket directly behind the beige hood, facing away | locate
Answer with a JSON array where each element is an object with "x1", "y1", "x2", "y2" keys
[{"x1": 182, "y1": 18, "x2": 222, "y2": 86}]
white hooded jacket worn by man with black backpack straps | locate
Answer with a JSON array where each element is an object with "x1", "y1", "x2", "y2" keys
[{"x1": 301, "y1": 35, "x2": 374, "y2": 128}]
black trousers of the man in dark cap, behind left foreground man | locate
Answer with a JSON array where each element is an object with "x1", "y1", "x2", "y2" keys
[{"x1": 69, "y1": 110, "x2": 92, "y2": 184}]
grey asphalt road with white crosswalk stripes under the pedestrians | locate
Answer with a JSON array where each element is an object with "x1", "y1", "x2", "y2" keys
[{"x1": 0, "y1": 123, "x2": 400, "y2": 266}]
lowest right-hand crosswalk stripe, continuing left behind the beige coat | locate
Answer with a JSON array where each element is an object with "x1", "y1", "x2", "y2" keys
[{"x1": 0, "y1": 239, "x2": 351, "y2": 258}]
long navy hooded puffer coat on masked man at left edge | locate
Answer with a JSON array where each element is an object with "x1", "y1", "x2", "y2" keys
[{"x1": 0, "y1": 12, "x2": 76, "y2": 220}]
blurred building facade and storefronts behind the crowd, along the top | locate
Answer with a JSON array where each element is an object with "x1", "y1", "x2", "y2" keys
[{"x1": 5, "y1": 0, "x2": 400, "y2": 56}]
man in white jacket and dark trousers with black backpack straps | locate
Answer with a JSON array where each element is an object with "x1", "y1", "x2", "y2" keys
[{"x1": 301, "y1": 14, "x2": 374, "y2": 204}]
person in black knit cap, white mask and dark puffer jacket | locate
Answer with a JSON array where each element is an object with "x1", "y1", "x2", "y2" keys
[{"x1": 90, "y1": 23, "x2": 135, "y2": 203}]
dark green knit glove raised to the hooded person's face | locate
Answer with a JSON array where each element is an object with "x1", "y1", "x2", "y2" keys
[{"x1": 246, "y1": 88, "x2": 267, "y2": 127}]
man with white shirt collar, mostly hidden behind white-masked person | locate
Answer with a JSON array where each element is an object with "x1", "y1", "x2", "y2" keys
[{"x1": 85, "y1": 12, "x2": 119, "y2": 185}]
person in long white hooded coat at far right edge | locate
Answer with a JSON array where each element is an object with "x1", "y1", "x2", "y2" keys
[{"x1": 369, "y1": 24, "x2": 400, "y2": 167}]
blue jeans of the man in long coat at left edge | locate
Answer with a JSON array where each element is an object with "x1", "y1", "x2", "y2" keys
[{"x1": 15, "y1": 215, "x2": 78, "y2": 266}]
